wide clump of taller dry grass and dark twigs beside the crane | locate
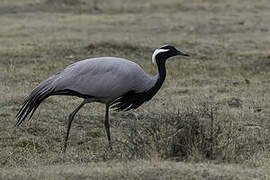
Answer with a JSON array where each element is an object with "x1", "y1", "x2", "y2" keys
[{"x1": 102, "y1": 99, "x2": 269, "y2": 163}]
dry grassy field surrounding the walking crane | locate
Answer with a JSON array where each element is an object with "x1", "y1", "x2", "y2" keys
[{"x1": 0, "y1": 0, "x2": 270, "y2": 179}]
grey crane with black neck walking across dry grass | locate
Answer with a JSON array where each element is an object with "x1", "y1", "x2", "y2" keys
[{"x1": 16, "y1": 45, "x2": 188, "y2": 152}]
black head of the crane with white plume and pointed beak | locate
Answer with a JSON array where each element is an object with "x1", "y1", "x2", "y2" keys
[{"x1": 152, "y1": 44, "x2": 189, "y2": 64}]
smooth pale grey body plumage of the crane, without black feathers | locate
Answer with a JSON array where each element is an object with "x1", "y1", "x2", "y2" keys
[{"x1": 51, "y1": 57, "x2": 156, "y2": 103}]
